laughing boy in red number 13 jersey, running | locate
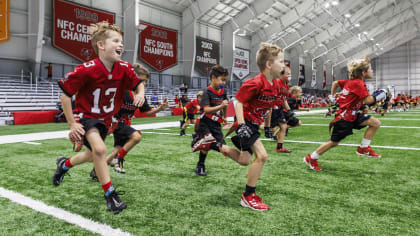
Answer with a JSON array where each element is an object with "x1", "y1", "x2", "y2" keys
[{"x1": 52, "y1": 22, "x2": 144, "y2": 214}]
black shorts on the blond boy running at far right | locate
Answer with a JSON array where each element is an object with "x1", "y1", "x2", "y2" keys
[{"x1": 331, "y1": 113, "x2": 370, "y2": 142}]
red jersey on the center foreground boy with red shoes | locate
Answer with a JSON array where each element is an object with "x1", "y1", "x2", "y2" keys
[{"x1": 235, "y1": 73, "x2": 280, "y2": 124}]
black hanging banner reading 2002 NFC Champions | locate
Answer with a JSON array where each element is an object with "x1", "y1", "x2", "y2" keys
[{"x1": 194, "y1": 37, "x2": 220, "y2": 76}]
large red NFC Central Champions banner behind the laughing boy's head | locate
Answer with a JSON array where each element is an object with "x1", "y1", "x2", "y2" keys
[{"x1": 53, "y1": 0, "x2": 115, "y2": 62}]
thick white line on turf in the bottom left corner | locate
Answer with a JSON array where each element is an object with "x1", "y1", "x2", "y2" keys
[{"x1": 0, "y1": 187, "x2": 131, "y2": 236}]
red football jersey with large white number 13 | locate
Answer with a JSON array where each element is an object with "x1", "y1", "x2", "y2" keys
[{"x1": 58, "y1": 59, "x2": 141, "y2": 119}]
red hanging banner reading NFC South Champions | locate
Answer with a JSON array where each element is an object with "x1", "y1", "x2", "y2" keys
[{"x1": 139, "y1": 22, "x2": 178, "y2": 71}]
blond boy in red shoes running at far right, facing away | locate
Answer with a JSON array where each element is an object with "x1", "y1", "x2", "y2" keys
[{"x1": 303, "y1": 57, "x2": 387, "y2": 171}]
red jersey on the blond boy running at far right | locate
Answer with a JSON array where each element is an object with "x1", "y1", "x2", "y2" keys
[{"x1": 336, "y1": 79, "x2": 369, "y2": 122}]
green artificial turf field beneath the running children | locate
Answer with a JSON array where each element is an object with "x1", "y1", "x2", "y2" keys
[{"x1": 0, "y1": 110, "x2": 420, "y2": 235}]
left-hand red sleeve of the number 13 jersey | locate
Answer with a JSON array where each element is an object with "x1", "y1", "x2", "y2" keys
[{"x1": 58, "y1": 64, "x2": 90, "y2": 97}]
